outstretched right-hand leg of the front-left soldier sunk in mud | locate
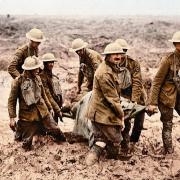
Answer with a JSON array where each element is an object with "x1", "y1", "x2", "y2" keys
[{"x1": 42, "y1": 115, "x2": 66, "y2": 141}]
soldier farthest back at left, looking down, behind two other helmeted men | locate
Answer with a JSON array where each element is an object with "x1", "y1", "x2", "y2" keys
[{"x1": 8, "y1": 28, "x2": 45, "y2": 79}]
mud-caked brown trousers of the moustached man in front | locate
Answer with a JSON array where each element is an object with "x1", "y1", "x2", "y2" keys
[{"x1": 92, "y1": 122, "x2": 122, "y2": 158}]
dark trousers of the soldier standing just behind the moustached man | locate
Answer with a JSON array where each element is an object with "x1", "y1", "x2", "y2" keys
[{"x1": 121, "y1": 112, "x2": 145, "y2": 149}]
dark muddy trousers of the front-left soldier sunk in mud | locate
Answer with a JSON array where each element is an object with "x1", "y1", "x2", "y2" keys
[{"x1": 15, "y1": 115, "x2": 65, "y2": 150}]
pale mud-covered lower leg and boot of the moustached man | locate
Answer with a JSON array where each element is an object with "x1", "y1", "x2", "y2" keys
[{"x1": 86, "y1": 143, "x2": 105, "y2": 166}]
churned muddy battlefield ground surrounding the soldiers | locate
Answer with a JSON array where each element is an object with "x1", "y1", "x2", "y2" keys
[{"x1": 0, "y1": 16, "x2": 180, "y2": 180}]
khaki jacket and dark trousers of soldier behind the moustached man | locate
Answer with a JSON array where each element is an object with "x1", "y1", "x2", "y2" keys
[{"x1": 121, "y1": 56, "x2": 146, "y2": 148}]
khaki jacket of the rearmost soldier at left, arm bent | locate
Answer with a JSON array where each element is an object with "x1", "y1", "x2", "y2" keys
[{"x1": 8, "y1": 44, "x2": 38, "y2": 79}]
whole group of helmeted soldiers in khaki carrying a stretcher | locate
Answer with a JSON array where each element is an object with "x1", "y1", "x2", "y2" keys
[{"x1": 8, "y1": 28, "x2": 180, "y2": 165}]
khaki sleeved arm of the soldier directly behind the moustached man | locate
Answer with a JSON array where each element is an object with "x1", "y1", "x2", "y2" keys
[{"x1": 131, "y1": 62, "x2": 143, "y2": 103}]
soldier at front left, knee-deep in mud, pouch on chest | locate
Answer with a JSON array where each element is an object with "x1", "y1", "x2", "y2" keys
[{"x1": 8, "y1": 56, "x2": 65, "y2": 150}]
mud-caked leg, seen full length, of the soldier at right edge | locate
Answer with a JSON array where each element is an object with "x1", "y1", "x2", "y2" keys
[{"x1": 158, "y1": 103, "x2": 173, "y2": 154}]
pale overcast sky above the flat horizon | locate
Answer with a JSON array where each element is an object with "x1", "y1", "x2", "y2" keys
[{"x1": 0, "y1": 0, "x2": 180, "y2": 15}]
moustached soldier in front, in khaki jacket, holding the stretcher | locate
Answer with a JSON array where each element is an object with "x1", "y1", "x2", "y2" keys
[{"x1": 86, "y1": 43, "x2": 124, "y2": 165}]
